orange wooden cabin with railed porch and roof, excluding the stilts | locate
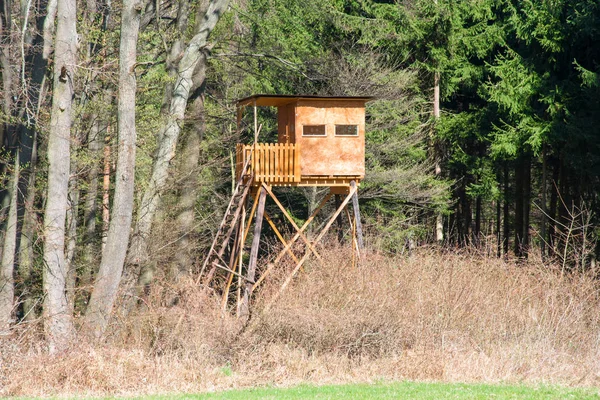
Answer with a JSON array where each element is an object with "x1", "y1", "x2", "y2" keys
[{"x1": 237, "y1": 95, "x2": 370, "y2": 187}]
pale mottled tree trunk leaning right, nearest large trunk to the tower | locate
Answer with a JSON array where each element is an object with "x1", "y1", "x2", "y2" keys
[{"x1": 129, "y1": 0, "x2": 229, "y2": 272}]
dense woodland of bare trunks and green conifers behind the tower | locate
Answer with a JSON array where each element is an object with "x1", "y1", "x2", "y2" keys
[{"x1": 0, "y1": 0, "x2": 600, "y2": 351}]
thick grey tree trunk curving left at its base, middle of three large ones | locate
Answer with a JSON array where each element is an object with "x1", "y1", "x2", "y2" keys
[{"x1": 85, "y1": 0, "x2": 142, "y2": 338}]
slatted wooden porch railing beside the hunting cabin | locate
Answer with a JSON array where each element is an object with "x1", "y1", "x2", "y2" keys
[{"x1": 235, "y1": 143, "x2": 300, "y2": 183}]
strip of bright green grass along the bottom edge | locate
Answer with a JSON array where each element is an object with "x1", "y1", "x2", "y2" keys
[{"x1": 142, "y1": 382, "x2": 600, "y2": 400}]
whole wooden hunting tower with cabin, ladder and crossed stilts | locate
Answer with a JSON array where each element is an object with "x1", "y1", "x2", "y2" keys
[{"x1": 200, "y1": 95, "x2": 371, "y2": 316}]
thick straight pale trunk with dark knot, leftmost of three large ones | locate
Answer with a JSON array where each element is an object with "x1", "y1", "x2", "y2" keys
[{"x1": 44, "y1": 0, "x2": 77, "y2": 353}]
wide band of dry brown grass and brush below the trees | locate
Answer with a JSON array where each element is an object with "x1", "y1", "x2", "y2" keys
[{"x1": 0, "y1": 249, "x2": 600, "y2": 395}]
